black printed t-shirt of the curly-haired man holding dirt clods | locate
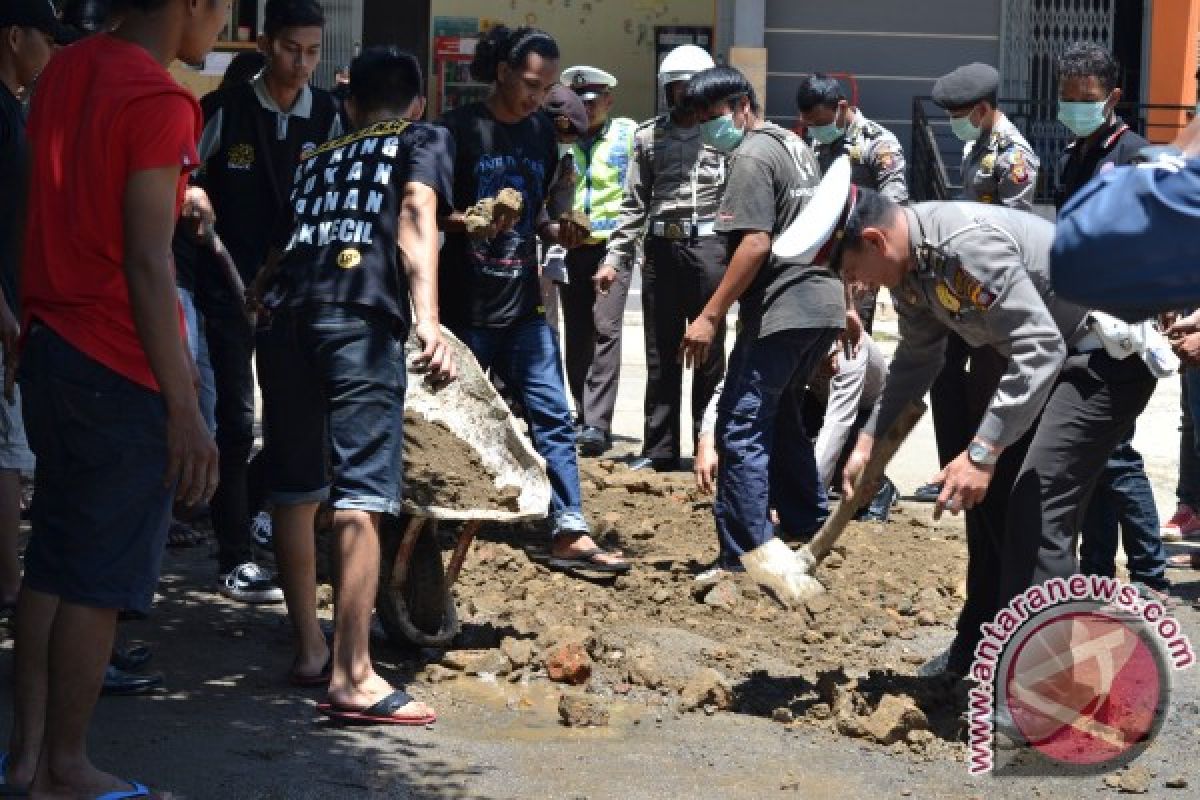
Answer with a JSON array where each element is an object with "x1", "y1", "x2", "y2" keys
[{"x1": 438, "y1": 103, "x2": 558, "y2": 327}]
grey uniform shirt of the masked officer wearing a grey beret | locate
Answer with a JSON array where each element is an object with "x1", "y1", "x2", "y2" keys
[{"x1": 962, "y1": 115, "x2": 1040, "y2": 211}]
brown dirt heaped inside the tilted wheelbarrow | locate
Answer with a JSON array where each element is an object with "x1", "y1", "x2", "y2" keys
[{"x1": 404, "y1": 413, "x2": 521, "y2": 511}]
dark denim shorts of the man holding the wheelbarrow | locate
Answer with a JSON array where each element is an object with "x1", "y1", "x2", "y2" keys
[{"x1": 257, "y1": 305, "x2": 406, "y2": 513}]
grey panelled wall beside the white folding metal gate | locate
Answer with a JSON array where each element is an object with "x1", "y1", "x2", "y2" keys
[{"x1": 766, "y1": 0, "x2": 1002, "y2": 163}]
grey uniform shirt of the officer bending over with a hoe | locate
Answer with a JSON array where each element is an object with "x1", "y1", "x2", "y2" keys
[{"x1": 866, "y1": 203, "x2": 1087, "y2": 447}]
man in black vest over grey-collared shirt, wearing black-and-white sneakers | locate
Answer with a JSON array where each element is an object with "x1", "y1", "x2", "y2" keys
[{"x1": 183, "y1": 0, "x2": 342, "y2": 603}]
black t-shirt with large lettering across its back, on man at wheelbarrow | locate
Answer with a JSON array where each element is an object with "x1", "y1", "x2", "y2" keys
[{"x1": 266, "y1": 120, "x2": 454, "y2": 325}]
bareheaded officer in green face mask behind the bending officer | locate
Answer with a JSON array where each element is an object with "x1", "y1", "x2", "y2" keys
[{"x1": 796, "y1": 72, "x2": 908, "y2": 332}]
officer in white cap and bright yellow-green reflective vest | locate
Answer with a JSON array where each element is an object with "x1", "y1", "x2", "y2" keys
[{"x1": 559, "y1": 67, "x2": 637, "y2": 456}]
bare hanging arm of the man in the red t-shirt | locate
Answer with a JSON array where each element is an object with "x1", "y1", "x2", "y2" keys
[{"x1": 124, "y1": 167, "x2": 217, "y2": 504}]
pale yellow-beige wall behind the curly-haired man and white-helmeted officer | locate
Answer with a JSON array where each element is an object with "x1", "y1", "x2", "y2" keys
[{"x1": 431, "y1": 0, "x2": 716, "y2": 120}]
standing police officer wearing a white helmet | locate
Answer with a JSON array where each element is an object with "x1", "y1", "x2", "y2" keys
[{"x1": 596, "y1": 44, "x2": 726, "y2": 470}]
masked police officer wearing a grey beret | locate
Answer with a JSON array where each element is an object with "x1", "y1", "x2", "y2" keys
[{"x1": 917, "y1": 64, "x2": 1039, "y2": 501}]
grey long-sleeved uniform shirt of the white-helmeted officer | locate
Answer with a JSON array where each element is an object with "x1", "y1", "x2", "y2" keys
[{"x1": 605, "y1": 114, "x2": 726, "y2": 270}]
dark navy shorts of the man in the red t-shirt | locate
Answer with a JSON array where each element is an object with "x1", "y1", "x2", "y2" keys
[{"x1": 20, "y1": 323, "x2": 174, "y2": 612}]
